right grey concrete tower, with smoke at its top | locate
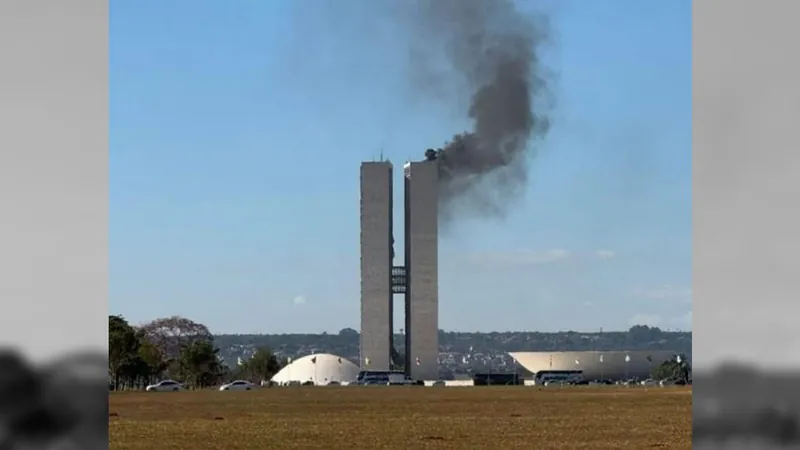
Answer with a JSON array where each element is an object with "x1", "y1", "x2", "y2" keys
[{"x1": 404, "y1": 161, "x2": 439, "y2": 380}]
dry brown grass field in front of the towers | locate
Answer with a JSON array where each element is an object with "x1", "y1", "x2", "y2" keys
[{"x1": 109, "y1": 387, "x2": 692, "y2": 450}]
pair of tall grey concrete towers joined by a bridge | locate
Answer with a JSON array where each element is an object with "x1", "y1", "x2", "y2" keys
[{"x1": 360, "y1": 160, "x2": 439, "y2": 380}]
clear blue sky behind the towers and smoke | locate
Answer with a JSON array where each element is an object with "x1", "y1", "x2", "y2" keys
[{"x1": 109, "y1": 0, "x2": 692, "y2": 333}]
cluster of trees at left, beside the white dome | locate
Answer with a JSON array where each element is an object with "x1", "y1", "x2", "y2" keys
[{"x1": 108, "y1": 315, "x2": 287, "y2": 390}]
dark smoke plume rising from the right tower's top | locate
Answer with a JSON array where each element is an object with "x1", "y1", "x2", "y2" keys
[{"x1": 416, "y1": 0, "x2": 552, "y2": 219}]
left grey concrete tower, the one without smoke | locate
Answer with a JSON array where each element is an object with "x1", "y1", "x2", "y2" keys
[{"x1": 360, "y1": 162, "x2": 393, "y2": 370}]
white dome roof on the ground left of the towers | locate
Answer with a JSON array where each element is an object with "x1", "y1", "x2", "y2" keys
[{"x1": 272, "y1": 353, "x2": 360, "y2": 385}]
